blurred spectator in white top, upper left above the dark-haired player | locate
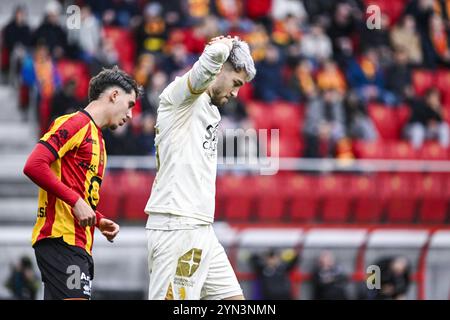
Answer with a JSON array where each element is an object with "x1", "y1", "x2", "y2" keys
[{"x1": 67, "y1": 6, "x2": 101, "y2": 63}]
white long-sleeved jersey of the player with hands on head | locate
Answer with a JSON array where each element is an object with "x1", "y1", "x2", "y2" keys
[{"x1": 145, "y1": 43, "x2": 230, "y2": 223}]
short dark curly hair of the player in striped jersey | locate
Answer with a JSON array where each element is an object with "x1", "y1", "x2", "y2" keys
[{"x1": 89, "y1": 66, "x2": 142, "y2": 102}]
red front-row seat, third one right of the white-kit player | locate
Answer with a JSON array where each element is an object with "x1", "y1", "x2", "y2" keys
[{"x1": 285, "y1": 175, "x2": 319, "y2": 222}]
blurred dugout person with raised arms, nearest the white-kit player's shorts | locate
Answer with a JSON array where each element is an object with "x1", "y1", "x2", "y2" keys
[{"x1": 250, "y1": 249, "x2": 298, "y2": 300}]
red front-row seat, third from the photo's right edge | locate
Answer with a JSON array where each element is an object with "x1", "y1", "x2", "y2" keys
[{"x1": 349, "y1": 175, "x2": 383, "y2": 223}]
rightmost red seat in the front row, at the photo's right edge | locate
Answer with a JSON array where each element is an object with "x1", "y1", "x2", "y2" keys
[{"x1": 415, "y1": 173, "x2": 448, "y2": 223}]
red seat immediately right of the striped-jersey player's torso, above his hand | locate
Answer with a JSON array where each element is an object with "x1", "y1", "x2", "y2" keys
[{"x1": 97, "y1": 171, "x2": 123, "y2": 220}]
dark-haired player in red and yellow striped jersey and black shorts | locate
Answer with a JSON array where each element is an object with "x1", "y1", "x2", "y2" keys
[{"x1": 24, "y1": 67, "x2": 140, "y2": 299}]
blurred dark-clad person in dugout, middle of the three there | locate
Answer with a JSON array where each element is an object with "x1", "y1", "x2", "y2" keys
[{"x1": 311, "y1": 251, "x2": 348, "y2": 300}]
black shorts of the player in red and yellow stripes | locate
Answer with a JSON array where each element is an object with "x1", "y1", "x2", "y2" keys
[{"x1": 34, "y1": 238, "x2": 94, "y2": 300}]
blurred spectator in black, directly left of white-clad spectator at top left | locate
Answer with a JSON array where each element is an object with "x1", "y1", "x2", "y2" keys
[{"x1": 32, "y1": 1, "x2": 68, "y2": 58}]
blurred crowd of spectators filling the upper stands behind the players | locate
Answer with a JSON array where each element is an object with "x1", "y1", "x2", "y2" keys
[{"x1": 1, "y1": 0, "x2": 450, "y2": 157}]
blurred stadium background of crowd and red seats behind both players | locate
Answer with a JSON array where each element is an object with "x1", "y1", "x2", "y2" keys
[{"x1": 0, "y1": 0, "x2": 450, "y2": 299}]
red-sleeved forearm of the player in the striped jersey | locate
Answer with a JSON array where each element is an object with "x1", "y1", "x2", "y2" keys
[{"x1": 23, "y1": 144, "x2": 80, "y2": 207}]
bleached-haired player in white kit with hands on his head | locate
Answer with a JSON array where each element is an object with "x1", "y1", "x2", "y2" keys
[{"x1": 145, "y1": 36, "x2": 256, "y2": 300}]
